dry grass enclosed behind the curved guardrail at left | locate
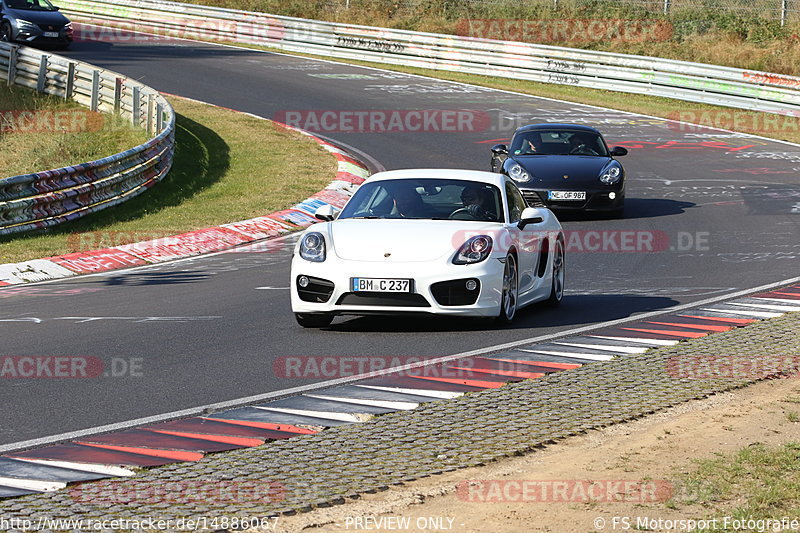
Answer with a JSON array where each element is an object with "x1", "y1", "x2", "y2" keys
[{"x1": 0, "y1": 86, "x2": 147, "y2": 177}]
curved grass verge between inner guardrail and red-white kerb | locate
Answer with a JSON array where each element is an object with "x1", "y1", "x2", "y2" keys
[{"x1": 0, "y1": 98, "x2": 336, "y2": 263}]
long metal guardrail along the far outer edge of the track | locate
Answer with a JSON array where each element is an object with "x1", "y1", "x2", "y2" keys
[{"x1": 54, "y1": 0, "x2": 800, "y2": 115}]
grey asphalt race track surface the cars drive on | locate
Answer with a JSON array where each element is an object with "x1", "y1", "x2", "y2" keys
[{"x1": 0, "y1": 32, "x2": 800, "y2": 445}]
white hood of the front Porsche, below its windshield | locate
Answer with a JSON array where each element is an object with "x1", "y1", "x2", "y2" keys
[{"x1": 330, "y1": 219, "x2": 502, "y2": 263}]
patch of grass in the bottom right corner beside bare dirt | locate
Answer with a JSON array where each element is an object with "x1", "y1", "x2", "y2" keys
[{"x1": 670, "y1": 442, "x2": 800, "y2": 531}]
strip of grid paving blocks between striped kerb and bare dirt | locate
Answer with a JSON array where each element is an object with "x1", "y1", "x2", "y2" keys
[{"x1": 0, "y1": 313, "x2": 800, "y2": 531}]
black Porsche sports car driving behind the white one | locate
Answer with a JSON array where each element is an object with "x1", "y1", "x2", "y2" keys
[{"x1": 492, "y1": 124, "x2": 628, "y2": 216}]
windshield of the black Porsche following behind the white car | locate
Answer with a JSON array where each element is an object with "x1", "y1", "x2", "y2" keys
[{"x1": 509, "y1": 129, "x2": 608, "y2": 157}]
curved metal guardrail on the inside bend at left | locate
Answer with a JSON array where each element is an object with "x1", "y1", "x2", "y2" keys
[{"x1": 0, "y1": 43, "x2": 175, "y2": 235}]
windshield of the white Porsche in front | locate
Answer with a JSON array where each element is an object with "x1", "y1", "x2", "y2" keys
[{"x1": 339, "y1": 178, "x2": 503, "y2": 222}]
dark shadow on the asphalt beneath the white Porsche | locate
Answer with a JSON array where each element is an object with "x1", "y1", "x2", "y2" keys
[{"x1": 324, "y1": 294, "x2": 679, "y2": 333}]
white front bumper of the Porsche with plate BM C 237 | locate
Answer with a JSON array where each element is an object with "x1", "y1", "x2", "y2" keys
[{"x1": 290, "y1": 254, "x2": 505, "y2": 317}]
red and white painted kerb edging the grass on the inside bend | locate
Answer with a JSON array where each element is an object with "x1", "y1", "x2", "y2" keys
[{"x1": 0, "y1": 119, "x2": 369, "y2": 286}]
